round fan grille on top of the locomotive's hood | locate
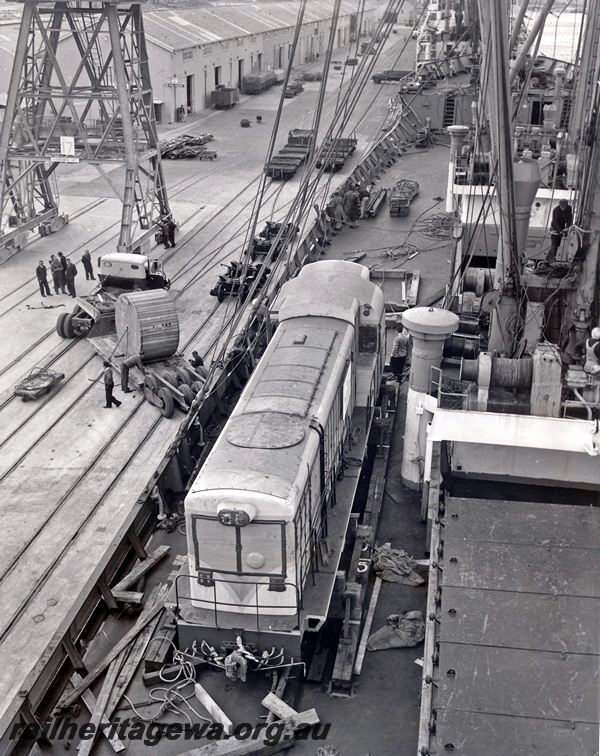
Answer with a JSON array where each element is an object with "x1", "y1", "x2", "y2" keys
[{"x1": 227, "y1": 412, "x2": 304, "y2": 449}]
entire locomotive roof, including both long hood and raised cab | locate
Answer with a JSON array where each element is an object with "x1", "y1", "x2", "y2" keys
[{"x1": 191, "y1": 260, "x2": 384, "y2": 508}]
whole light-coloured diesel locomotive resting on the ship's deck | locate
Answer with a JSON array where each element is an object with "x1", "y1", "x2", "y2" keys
[{"x1": 178, "y1": 261, "x2": 385, "y2": 658}]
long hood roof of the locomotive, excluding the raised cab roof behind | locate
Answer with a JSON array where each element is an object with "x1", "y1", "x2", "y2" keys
[{"x1": 192, "y1": 318, "x2": 353, "y2": 500}]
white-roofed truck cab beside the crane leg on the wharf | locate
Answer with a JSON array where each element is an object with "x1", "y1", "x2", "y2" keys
[{"x1": 98, "y1": 252, "x2": 170, "y2": 291}]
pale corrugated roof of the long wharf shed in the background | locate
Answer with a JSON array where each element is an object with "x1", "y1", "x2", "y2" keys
[{"x1": 144, "y1": 0, "x2": 377, "y2": 50}]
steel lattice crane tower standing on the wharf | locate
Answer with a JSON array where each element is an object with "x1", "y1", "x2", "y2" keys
[{"x1": 0, "y1": 0, "x2": 170, "y2": 262}]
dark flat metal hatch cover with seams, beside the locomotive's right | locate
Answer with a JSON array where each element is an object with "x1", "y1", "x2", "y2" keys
[{"x1": 433, "y1": 499, "x2": 600, "y2": 756}]
